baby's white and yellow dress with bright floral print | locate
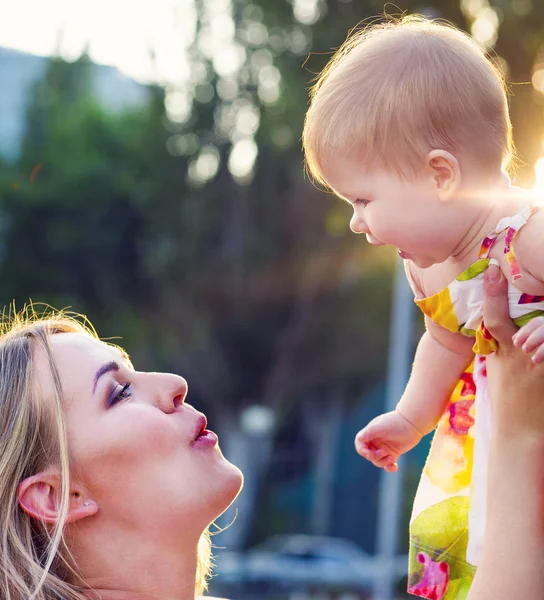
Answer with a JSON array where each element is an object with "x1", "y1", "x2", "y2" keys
[{"x1": 408, "y1": 208, "x2": 544, "y2": 600}]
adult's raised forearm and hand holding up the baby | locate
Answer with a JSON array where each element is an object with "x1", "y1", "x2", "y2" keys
[{"x1": 467, "y1": 264, "x2": 544, "y2": 600}]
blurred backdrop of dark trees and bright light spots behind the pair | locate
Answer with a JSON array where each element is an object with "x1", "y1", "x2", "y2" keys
[{"x1": 0, "y1": 0, "x2": 544, "y2": 600}]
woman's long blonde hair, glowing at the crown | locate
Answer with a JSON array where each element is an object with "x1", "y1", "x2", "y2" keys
[{"x1": 0, "y1": 307, "x2": 211, "y2": 600}]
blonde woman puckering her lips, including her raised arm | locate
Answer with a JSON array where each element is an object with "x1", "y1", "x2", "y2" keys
[{"x1": 0, "y1": 262, "x2": 544, "y2": 600}]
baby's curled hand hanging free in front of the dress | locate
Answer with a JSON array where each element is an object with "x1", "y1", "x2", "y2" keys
[{"x1": 355, "y1": 411, "x2": 423, "y2": 473}]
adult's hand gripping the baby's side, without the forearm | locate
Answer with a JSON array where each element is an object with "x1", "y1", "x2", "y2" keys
[{"x1": 484, "y1": 264, "x2": 544, "y2": 441}]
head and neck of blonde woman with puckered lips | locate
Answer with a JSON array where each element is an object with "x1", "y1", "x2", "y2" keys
[{"x1": 0, "y1": 315, "x2": 242, "y2": 600}]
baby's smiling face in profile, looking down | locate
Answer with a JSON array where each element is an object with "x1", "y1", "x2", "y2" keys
[{"x1": 324, "y1": 157, "x2": 466, "y2": 268}]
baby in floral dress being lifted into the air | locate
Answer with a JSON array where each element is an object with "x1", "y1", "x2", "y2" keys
[{"x1": 303, "y1": 17, "x2": 544, "y2": 600}]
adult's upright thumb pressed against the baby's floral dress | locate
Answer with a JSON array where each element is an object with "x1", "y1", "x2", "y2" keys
[{"x1": 484, "y1": 259, "x2": 517, "y2": 345}]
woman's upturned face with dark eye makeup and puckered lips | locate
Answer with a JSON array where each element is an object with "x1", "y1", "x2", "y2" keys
[{"x1": 36, "y1": 333, "x2": 242, "y2": 536}]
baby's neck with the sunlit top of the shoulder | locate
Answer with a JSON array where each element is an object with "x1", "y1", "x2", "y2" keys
[{"x1": 449, "y1": 185, "x2": 531, "y2": 263}]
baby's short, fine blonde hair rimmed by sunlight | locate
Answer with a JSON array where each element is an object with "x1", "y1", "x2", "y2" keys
[{"x1": 302, "y1": 15, "x2": 513, "y2": 185}]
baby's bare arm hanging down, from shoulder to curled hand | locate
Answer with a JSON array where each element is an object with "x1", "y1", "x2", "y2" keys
[{"x1": 355, "y1": 319, "x2": 473, "y2": 472}]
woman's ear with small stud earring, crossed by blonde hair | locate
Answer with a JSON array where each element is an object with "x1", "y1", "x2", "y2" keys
[{"x1": 17, "y1": 471, "x2": 98, "y2": 525}]
